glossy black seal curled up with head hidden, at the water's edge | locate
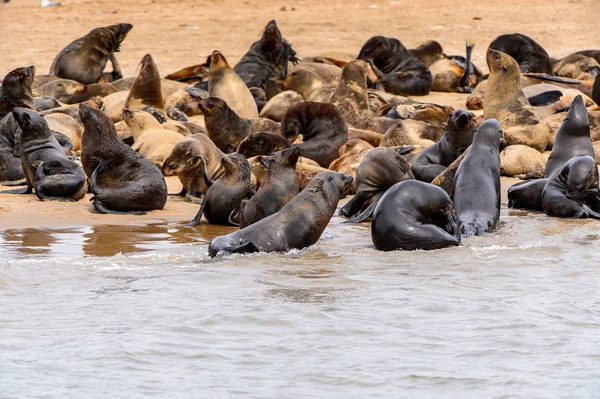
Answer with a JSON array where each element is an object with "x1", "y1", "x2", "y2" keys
[{"x1": 371, "y1": 180, "x2": 461, "y2": 251}]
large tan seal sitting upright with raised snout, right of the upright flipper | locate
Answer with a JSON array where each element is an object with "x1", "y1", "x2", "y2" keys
[{"x1": 483, "y1": 49, "x2": 550, "y2": 152}]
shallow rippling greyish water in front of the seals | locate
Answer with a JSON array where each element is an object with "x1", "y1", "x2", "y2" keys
[{"x1": 0, "y1": 205, "x2": 600, "y2": 398}]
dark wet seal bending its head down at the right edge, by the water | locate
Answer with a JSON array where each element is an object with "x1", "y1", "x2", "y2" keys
[{"x1": 542, "y1": 155, "x2": 600, "y2": 219}]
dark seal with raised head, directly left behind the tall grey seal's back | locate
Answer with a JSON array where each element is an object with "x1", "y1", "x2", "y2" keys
[{"x1": 412, "y1": 109, "x2": 475, "y2": 183}]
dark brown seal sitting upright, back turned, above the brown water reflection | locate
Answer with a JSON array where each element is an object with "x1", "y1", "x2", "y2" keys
[{"x1": 79, "y1": 104, "x2": 167, "y2": 215}]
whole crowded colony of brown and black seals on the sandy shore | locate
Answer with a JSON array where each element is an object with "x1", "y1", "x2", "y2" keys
[{"x1": 0, "y1": 21, "x2": 600, "y2": 257}]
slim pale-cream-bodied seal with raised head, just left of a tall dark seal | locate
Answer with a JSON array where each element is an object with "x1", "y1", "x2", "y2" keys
[{"x1": 208, "y1": 50, "x2": 258, "y2": 119}]
